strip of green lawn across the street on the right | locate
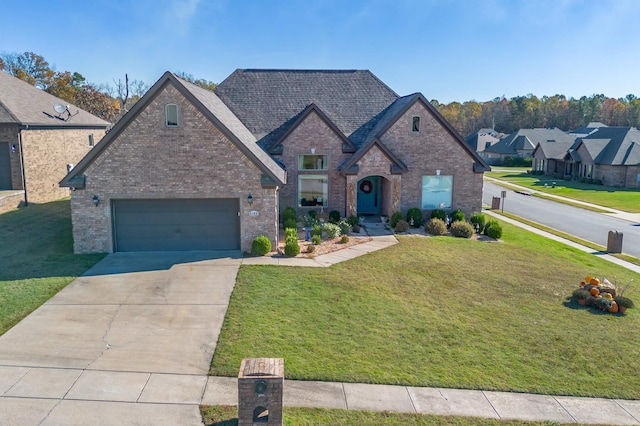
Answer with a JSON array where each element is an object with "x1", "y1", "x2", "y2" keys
[{"x1": 485, "y1": 171, "x2": 640, "y2": 213}]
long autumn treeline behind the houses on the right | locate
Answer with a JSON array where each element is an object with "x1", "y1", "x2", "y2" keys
[{"x1": 431, "y1": 94, "x2": 640, "y2": 137}]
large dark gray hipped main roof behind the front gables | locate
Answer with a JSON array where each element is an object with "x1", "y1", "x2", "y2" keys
[{"x1": 214, "y1": 69, "x2": 398, "y2": 146}]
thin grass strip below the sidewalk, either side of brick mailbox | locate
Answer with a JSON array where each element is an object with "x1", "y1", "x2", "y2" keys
[{"x1": 200, "y1": 405, "x2": 555, "y2": 426}]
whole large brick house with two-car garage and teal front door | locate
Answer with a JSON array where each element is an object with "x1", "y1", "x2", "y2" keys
[{"x1": 61, "y1": 70, "x2": 489, "y2": 253}]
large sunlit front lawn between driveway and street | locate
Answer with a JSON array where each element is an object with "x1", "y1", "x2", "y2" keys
[{"x1": 211, "y1": 223, "x2": 640, "y2": 399}]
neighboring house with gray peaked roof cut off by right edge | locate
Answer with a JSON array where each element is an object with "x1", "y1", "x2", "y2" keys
[{"x1": 574, "y1": 127, "x2": 640, "y2": 188}]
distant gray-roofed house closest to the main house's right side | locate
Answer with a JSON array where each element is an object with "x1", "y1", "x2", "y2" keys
[{"x1": 484, "y1": 127, "x2": 575, "y2": 164}]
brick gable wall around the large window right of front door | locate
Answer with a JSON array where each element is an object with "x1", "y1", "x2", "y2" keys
[{"x1": 372, "y1": 102, "x2": 483, "y2": 216}]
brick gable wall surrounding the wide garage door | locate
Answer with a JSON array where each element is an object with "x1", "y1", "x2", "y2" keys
[{"x1": 71, "y1": 85, "x2": 278, "y2": 253}]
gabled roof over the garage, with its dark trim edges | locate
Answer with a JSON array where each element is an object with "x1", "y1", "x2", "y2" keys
[{"x1": 60, "y1": 71, "x2": 286, "y2": 186}]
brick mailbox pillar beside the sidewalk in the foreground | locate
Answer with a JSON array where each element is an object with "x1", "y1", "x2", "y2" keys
[{"x1": 238, "y1": 358, "x2": 284, "y2": 426}]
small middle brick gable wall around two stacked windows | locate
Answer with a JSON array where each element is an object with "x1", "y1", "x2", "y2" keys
[{"x1": 276, "y1": 112, "x2": 351, "y2": 216}]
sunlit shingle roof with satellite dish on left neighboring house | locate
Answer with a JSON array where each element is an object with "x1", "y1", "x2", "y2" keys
[{"x1": 0, "y1": 71, "x2": 111, "y2": 127}]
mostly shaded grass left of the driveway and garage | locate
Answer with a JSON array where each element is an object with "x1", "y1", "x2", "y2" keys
[{"x1": 0, "y1": 200, "x2": 104, "y2": 334}]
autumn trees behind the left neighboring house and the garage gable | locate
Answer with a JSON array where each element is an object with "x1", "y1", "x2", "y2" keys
[{"x1": 0, "y1": 52, "x2": 215, "y2": 123}]
